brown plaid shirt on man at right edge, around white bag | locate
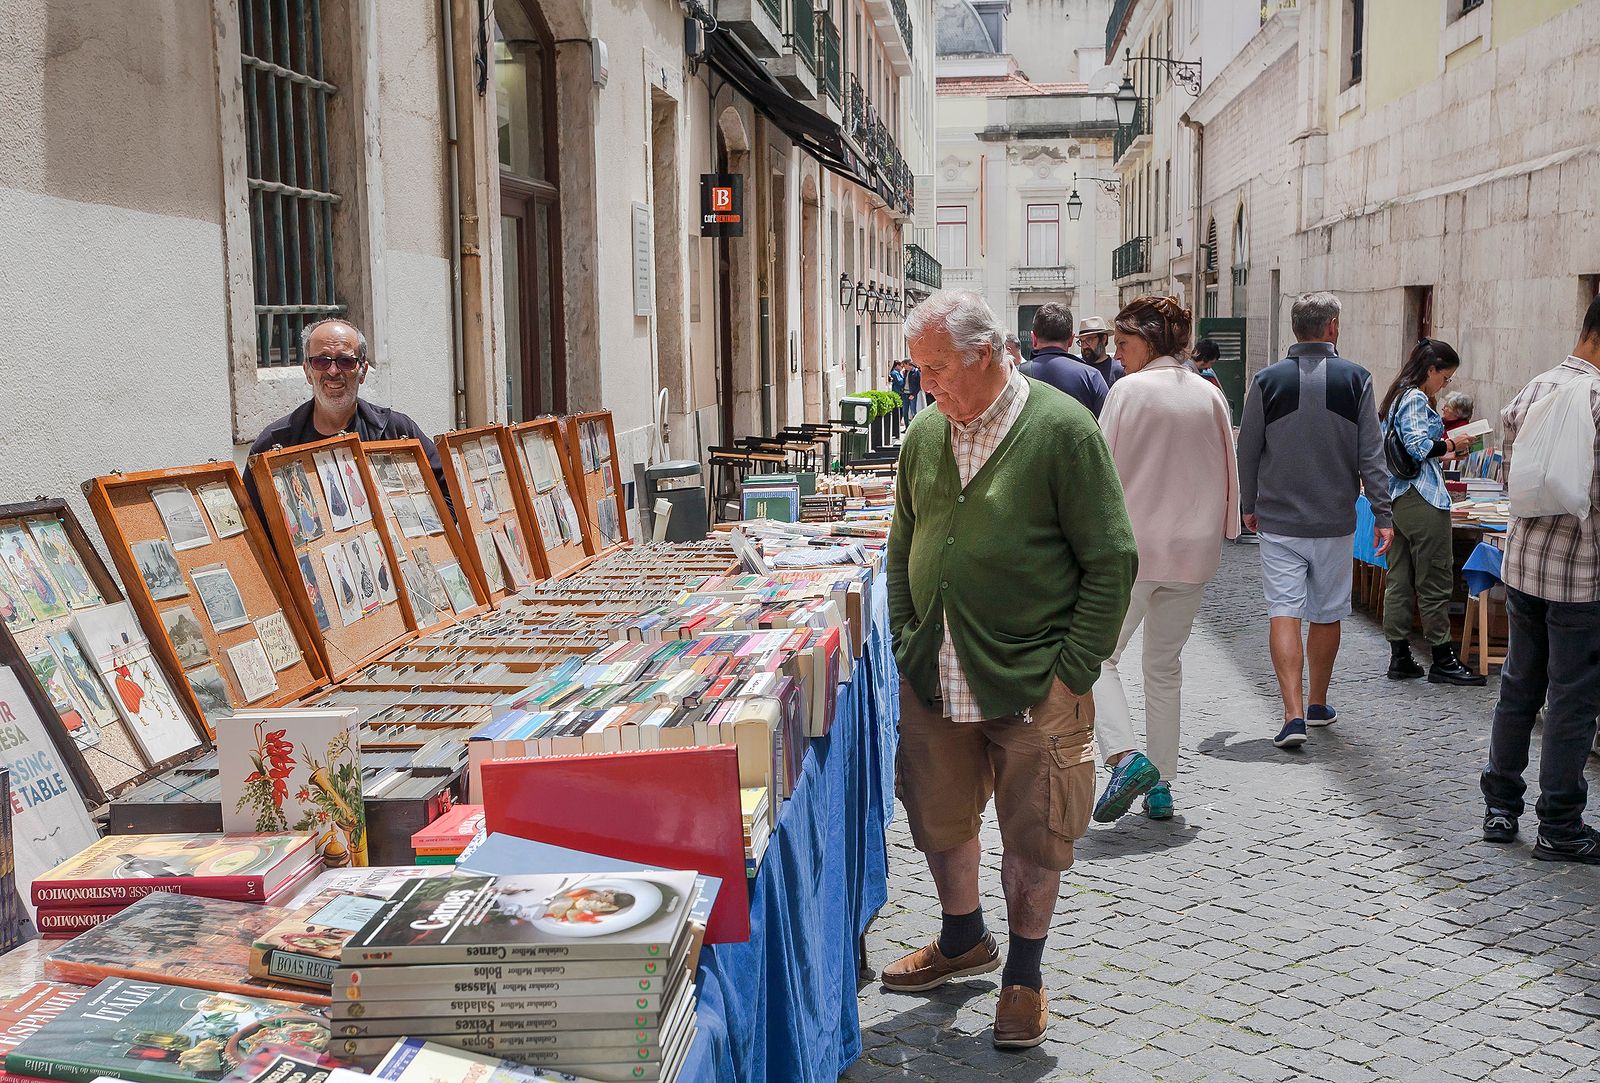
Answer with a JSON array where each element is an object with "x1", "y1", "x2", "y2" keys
[{"x1": 1501, "y1": 357, "x2": 1600, "y2": 601}]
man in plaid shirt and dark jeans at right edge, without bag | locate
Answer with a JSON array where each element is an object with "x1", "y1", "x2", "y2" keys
[{"x1": 1482, "y1": 298, "x2": 1600, "y2": 865}]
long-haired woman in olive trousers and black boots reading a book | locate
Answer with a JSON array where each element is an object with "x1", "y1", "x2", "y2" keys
[{"x1": 1378, "y1": 338, "x2": 1485, "y2": 685}]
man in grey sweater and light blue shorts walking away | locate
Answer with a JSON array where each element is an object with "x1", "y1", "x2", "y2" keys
[{"x1": 1238, "y1": 293, "x2": 1394, "y2": 749}]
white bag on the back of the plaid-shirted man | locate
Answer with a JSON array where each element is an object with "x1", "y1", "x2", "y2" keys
[{"x1": 1506, "y1": 379, "x2": 1595, "y2": 518}]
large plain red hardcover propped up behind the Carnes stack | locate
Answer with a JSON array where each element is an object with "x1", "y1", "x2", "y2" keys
[{"x1": 483, "y1": 745, "x2": 750, "y2": 944}]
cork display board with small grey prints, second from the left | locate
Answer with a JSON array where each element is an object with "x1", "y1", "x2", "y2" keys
[{"x1": 85, "y1": 462, "x2": 328, "y2": 737}]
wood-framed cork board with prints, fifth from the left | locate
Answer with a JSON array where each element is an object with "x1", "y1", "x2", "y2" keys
[{"x1": 435, "y1": 426, "x2": 549, "y2": 605}]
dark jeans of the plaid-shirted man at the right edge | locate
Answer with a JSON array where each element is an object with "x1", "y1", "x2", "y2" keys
[{"x1": 1482, "y1": 587, "x2": 1600, "y2": 838}]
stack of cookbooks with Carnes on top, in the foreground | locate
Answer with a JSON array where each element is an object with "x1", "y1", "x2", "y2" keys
[{"x1": 330, "y1": 872, "x2": 696, "y2": 1080}]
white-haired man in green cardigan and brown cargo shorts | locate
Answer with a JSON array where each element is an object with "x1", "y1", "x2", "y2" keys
[{"x1": 883, "y1": 291, "x2": 1138, "y2": 1048}]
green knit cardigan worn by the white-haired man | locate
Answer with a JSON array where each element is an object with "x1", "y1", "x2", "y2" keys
[{"x1": 888, "y1": 379, "x2": 1139, "y2": 718}]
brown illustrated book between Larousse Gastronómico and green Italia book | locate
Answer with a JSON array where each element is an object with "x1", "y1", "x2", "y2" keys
[{"x1": 45, "y1": 894, "x2": 328, "y2": 1005}]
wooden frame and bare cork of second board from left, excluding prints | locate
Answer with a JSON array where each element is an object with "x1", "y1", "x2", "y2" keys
[{"x1": 83, "y1": 461, "x2": 328, "y2": 739}]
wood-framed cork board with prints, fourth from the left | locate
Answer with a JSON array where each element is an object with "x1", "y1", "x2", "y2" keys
[{"x1": 362, "y1": 440, "x2": 488, "y2": 635}]
